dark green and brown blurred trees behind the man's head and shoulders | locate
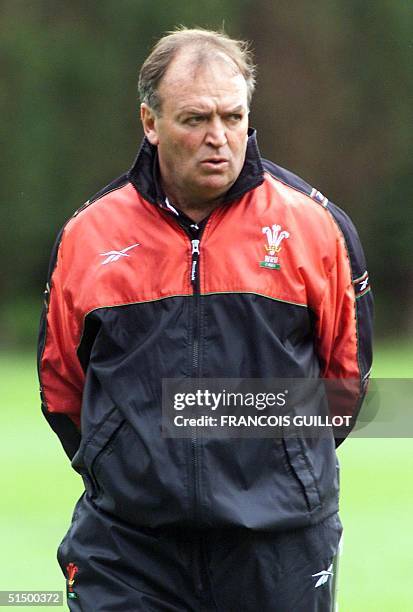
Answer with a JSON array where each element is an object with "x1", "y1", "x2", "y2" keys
[{"x1": 0, "y1": 0, "x2": 413, "y2": 342}]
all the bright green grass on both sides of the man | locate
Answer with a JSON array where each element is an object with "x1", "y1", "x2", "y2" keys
[{"x1": 0, "y1": 342, "x2": 413, "y2": 612}]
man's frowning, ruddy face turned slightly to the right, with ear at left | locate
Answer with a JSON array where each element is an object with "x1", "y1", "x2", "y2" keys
[{"x1": 142, "y1": 50, "x2": 248, "y2": 208}]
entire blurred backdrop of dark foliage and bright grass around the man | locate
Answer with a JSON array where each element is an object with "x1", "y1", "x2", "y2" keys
[{"x1": 0, "y1": 0, "x2": 413, "y2": 612}]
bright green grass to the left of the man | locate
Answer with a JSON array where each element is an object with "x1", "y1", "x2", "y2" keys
[{"x1": 0, "y1": 354, "x2": 82, "y2": 610}]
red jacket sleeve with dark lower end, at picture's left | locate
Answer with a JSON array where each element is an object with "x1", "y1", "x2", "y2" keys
[{"x1": 38, "y1": 230, "x2": 84, "y2": 459}]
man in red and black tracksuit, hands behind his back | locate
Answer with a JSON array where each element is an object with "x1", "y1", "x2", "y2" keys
[{"x1": 39, "y1": 30, "x2": 371, "y2": 612}]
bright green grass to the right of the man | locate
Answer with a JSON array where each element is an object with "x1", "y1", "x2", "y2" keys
[{"x1": 338, "y1": 341, "x2": 413, "y2": 612}]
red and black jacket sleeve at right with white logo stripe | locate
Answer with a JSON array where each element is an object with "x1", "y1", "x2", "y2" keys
[{"x1": 316, "y1": 203, "x2": 373, "y2": 446}]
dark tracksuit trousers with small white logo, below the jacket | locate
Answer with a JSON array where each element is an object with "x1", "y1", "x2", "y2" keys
[{"x1": 58, "y1": 496, "x2": 342, "y2": 612}]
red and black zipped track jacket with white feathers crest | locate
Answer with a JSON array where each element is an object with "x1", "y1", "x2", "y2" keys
[{"x1": 39, "y1": 131, "x2": 372, "y2": 530}]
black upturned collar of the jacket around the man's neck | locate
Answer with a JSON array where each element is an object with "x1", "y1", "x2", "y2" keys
[{"x1": 128, "y1": 129, "x2": 264, "y2": 209}]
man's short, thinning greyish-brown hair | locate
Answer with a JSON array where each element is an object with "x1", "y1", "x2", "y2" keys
[{"x1": 138, "y1": 27, "x2": 255, "y2": 114}]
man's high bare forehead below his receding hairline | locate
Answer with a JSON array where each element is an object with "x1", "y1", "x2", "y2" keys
[{"x1": 158, "y1": 49, "x2": 247, "y2": 111}]
